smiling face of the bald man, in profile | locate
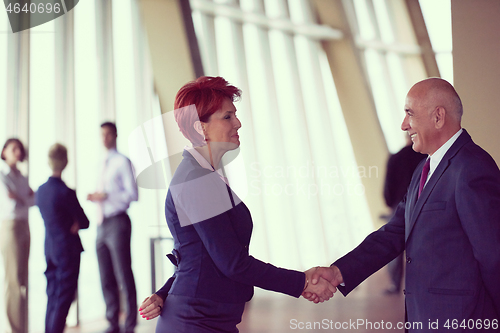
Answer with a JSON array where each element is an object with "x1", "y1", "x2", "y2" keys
[{"x1": 401, "y1": 88, "x2": 439, "y2": 155}]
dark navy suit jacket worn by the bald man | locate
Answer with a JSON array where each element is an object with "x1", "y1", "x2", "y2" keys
[{"x1": 334, "y1": 130, "x2": 500, "y2": 332}]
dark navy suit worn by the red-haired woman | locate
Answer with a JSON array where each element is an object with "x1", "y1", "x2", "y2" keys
[{"x1": 157, "y1": 151, "x2": 305, "y2": 333}]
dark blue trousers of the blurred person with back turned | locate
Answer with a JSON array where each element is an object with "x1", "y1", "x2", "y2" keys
[{"x1": 45, "y1": 251, "x2": 80, "y2": 333}]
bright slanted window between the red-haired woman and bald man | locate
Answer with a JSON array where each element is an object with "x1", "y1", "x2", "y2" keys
[{"x1": 190, "y1": 0, "x2": 372, "y2": 269}]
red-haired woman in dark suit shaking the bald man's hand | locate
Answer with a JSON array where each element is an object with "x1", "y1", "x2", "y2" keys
[{"x1": 139, "y1": 77, "x2": 335, "y2": 333}]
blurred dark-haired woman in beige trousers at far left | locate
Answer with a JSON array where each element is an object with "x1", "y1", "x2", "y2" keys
[{"x1": 0, "y1": 138, "x2": 35, "y2": 333}]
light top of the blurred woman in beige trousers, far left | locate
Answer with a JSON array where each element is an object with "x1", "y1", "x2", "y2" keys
[{"x1": 0, "y1": 161, "x2": 35, "y2": 221}]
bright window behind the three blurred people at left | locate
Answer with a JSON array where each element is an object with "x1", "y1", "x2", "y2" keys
[{"x1": 0, "y1": 0, "x2": 164, "y2": 332}]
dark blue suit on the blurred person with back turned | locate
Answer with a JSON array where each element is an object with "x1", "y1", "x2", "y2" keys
[{"x1": 36, "y1": 177, "x2": 89, "y2": 333}]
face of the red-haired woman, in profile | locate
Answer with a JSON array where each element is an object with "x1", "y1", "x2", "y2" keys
[{"x1": 203, "y1": 98, "x2": 241, "y2": 150}]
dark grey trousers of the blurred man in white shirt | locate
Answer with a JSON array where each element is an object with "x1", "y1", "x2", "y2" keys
[{"x1": 96, "y1": 213, "x2": 137, "y2": 333}]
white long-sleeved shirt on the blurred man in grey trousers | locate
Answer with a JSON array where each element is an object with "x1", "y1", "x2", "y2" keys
[{"x1": 98, "y1": 149, "x2": 139, "y2": 218}]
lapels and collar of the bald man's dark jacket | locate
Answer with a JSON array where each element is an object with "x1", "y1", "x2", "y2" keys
[{"x1": 405, "y1": 129, "x2": 472, "y2": 240}]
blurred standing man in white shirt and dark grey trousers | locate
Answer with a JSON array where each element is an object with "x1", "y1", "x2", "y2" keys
[{"x1": 87, "y1": 122, "x2": 138, "y2": 333}]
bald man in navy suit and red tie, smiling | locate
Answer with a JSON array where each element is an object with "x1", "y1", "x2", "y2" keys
[{"x1": 308, "y1": 78, "x2": 500, "y2": 333}]
